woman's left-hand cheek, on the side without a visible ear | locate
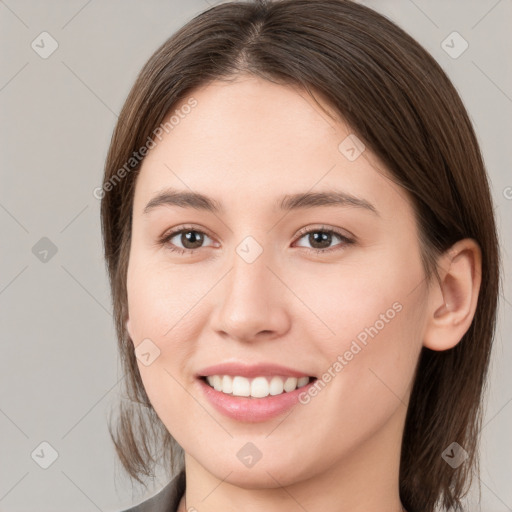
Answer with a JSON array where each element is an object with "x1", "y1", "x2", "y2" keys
[{"x1": 127, "y1": 255, "x2": 207, "y2": 416}]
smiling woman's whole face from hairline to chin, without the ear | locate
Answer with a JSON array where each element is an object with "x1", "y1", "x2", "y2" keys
[{"x1": 127, "y1": 76, "x2": 427, "y2": 488}]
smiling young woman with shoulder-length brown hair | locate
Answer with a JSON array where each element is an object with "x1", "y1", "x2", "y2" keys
[{"x1": 101, "y1": 0, "x2": 499, "y2": 512}]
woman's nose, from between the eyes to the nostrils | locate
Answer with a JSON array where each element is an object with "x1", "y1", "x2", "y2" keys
[{"x1": 211, "y1": 241, "x2": 293, "y2": 342}]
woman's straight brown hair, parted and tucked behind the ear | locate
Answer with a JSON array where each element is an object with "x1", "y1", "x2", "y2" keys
[{"x1": 101, "y1": 0, "x2": 500, "y2": 512}]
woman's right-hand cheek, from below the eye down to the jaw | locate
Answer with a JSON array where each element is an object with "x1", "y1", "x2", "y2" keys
[{"x1": 296, "y1": 252, "x2": 425, "y2": 414}]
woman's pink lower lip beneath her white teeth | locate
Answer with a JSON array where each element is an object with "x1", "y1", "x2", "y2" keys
[{"x1": 198, "y1": 379, "x2": 316, "y2": 423}]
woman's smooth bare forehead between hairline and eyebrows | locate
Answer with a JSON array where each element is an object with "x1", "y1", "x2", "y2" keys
[{"x1": 135, "y1": 76, "x2": 410, "y2": 218}]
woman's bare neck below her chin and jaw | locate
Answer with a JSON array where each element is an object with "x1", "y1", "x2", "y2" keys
[{"x1": 179, "y1": 408, "x2": 406, "y2": 512}]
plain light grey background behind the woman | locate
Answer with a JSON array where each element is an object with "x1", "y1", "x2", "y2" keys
[{"x1": 0, "y1": 0, "x2": 512, "y2": 512}]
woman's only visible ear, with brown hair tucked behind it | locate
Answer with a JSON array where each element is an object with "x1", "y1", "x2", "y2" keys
[{"x1": 423, "y1": 238, "x2": 482, "y2": 350}]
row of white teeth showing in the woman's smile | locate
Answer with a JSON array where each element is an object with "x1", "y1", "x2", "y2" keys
[{"x1": 206, "y1": 375, "x2": 309, "y2": 398}]
